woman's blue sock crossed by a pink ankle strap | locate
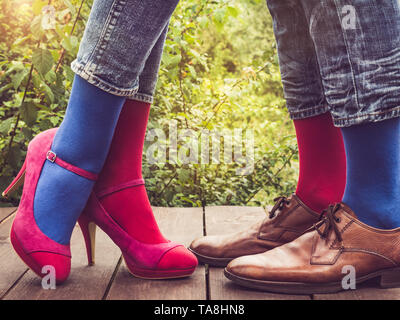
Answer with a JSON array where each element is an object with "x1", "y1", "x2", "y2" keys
[{"x1": 34, "y1": 76, "x2": 125, "y2": 244}]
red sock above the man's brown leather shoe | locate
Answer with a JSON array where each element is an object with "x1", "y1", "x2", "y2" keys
[{"x1": 294, "y1": 113, "x2": 346, "y2": 212}]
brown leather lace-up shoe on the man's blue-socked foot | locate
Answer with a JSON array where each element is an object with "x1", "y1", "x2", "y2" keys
[{"x1": 225, "y1": 203, "x2": 400, "y2": 294}]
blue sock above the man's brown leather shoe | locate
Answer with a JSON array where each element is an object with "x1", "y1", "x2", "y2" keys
[{"x1": 342, "y1": 118, "x2": 400, "y2": 229}]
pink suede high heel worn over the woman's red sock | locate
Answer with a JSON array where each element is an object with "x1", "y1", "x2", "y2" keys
[{"x1": 78, "y1": 179, "x2": 197, "y2": 279}]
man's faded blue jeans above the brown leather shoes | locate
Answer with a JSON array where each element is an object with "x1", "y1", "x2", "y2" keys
[{"x1": 267, "y1": 0, "x2": 400, "y2": 127}]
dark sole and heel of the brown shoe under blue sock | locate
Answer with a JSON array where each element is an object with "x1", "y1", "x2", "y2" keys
[{"x1": 224, "y1": 268, "x2": 400, "y2": 294}]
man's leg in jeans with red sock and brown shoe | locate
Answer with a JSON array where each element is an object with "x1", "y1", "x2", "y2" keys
[{"x1": 190, "y1": 0, "x2": 346, "y2": 266}]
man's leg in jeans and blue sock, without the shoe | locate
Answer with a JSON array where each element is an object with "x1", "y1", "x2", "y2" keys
[{"x1": 302, "y1": 0, "x2": 400, "y2": 229}]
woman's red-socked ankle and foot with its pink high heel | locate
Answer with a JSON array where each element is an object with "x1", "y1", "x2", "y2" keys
[{"x1": 78, "y1": 100, "x2": 197, "y2": 279}]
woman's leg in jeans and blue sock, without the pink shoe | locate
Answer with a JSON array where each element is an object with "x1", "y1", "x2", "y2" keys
[{"x1": 28, "y1": 0, "x2": 178, "y2": 244}]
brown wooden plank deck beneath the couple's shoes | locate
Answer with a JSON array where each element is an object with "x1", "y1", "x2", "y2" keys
[{"x1": 0, "y1": 207, "x2": 400, "y2": 300}]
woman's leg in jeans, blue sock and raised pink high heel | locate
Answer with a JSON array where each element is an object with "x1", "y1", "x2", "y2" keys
[{"x1": 3, "y1": 0, "x2": 181, "y2": 282}]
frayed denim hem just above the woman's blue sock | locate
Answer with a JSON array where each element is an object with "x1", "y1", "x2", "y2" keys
[{"x1": 71, "y1": 60, "x2": 139, "y2": 97}]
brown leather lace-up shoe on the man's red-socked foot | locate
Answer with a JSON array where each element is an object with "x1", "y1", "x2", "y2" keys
[{"x1": 189, "y1": 195, "x2": 320, "y2": 267}]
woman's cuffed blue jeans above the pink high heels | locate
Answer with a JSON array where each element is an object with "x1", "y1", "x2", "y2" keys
[{"x1": 71, "y1": 0, "x2": 179, "y2": 102}]
